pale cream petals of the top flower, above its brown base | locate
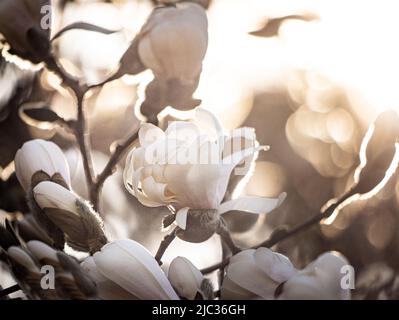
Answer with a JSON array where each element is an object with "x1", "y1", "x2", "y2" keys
[{"x1": 131, "y1": 2, "x2": 208, "y2": 84}]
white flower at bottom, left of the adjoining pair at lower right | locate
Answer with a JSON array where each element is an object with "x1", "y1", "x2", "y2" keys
[{"x1": 221, "y1": 248, "x2": 297, "y2": 300}]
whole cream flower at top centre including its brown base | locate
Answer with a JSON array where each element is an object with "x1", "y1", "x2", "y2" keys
[{"x1": 118, "y1": 1, "x2": 208, "y2": 114}]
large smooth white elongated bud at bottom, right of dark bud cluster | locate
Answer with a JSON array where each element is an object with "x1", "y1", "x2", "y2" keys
[{"x1": 94, "y1": 240, "x2": 178, "y2": 300}]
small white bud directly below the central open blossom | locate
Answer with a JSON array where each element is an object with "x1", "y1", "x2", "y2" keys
[{"x1": 168, "y1": 257, "x2": 204, "y2": 300}]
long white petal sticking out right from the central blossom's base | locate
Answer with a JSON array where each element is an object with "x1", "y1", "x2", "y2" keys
[{"x1": 219, "y1": 193, "x2": 287, "y2": 214}]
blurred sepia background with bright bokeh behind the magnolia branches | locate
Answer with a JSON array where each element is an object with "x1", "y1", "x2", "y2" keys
[{"x1": 0, "y1": 0, "x2": 399, "y2": 299}]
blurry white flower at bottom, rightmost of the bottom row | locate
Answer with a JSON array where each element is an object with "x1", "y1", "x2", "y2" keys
[{"x1": 279, "y1": 252, "x2": 351, "y2": 300}]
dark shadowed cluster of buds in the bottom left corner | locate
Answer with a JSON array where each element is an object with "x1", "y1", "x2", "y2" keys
[{"x1": 0, "y1": 220, "x2": 97, "y2": 300}]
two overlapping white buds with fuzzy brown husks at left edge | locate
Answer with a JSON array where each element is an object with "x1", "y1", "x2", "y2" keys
[{"x1": 15, "y1": 140, "x2": 107, "y2": 253}]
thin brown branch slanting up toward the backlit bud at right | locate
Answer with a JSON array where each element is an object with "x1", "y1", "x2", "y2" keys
[{"x1": 201, "y1": 189, "x2": 353, "y2": 274}]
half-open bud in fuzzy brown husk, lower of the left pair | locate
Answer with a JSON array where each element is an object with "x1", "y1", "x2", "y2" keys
[{"x1": 33, "y1": 181, "x2": 107, "y2": 253}]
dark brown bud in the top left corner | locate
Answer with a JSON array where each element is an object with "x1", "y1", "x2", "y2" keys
[{"x1": 0, "y1": 0, "x2": 51, "y2": 63}]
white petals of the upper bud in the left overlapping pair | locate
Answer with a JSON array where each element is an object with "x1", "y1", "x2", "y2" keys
[{"x1": 15, "y1": 139, "x2": 71, "y2": 191}]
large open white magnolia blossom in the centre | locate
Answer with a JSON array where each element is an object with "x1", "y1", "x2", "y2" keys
[{"x1": 124, "y1": 108, "x2": 285, "y2": 229}]
